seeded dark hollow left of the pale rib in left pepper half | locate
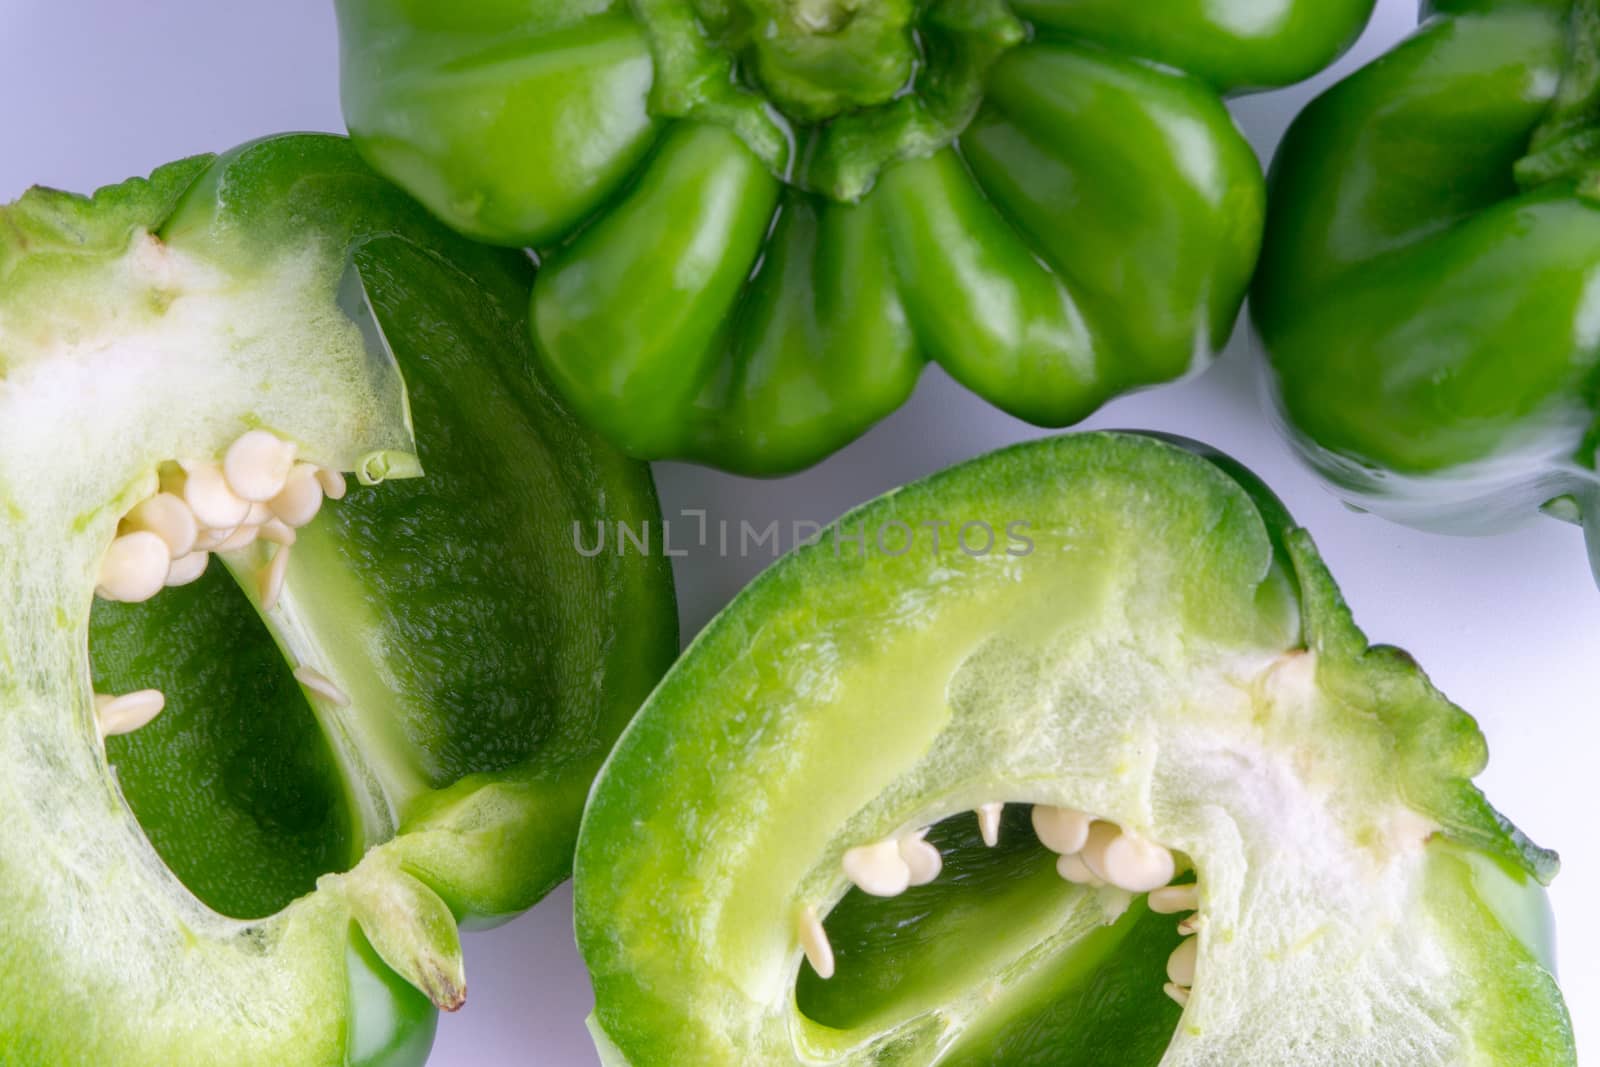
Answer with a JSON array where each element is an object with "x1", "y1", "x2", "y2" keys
[{"x1": 88, "y1": 430, "x2": 370, "y2": 918}]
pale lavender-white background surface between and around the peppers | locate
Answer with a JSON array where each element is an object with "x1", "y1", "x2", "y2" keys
[{"x1": 0, "y1": 0, "x2": 1600, "y2": 1065}]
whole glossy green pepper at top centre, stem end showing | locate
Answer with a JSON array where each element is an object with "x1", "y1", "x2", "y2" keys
[{"x1": 336, "y1": 0, "x2": 1371, "y2": 475}]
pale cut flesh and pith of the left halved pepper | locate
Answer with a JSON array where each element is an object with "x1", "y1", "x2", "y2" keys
[{"x1": 0, "y1": 234, "x2": 416, "y2": 1064}]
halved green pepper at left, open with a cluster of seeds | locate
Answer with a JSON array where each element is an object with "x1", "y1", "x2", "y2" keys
[{"x1": 0, "y1": 136, "x2": 677, "y2": 1067}]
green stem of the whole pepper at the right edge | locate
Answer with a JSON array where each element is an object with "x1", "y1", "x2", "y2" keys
[{"x1": 1515, "y1": 0, "x2": 1600, "y2": 200}]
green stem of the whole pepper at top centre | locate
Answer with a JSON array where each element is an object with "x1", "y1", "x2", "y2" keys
[{"x1": 632, "y1": 0, "x2": 1027, "y2": 202}]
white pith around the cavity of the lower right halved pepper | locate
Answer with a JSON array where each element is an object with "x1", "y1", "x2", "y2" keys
[{"x1": 614, "y1": 620, "x2": 1459, "y2": 1064}]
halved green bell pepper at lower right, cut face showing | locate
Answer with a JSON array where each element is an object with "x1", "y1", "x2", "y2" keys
[{"x1": 574, "y1": 434, "x2": 1574, "y2": 1067}]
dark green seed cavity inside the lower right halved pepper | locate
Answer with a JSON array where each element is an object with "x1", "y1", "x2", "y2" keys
[{"x1": 795, "y1": 801, "x2": 1203, "y2": 1030}]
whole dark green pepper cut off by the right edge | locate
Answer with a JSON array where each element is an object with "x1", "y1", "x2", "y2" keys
[{"x1": 1251, "y1": 0, "x2": 1600, "y2": 574}]
